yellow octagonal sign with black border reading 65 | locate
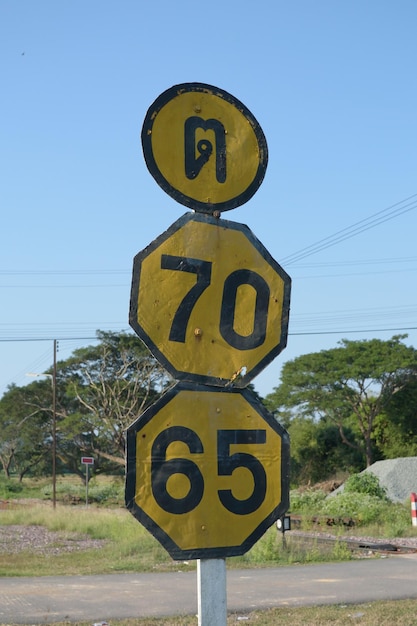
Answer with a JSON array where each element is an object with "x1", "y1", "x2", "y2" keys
[{"x1": 126, "y1": 383, "x2": 289, "y2": 559}]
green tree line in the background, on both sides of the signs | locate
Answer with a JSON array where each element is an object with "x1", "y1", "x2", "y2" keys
[{"x1": 0, "y1": 331, "x2": 417, "y2": 488}]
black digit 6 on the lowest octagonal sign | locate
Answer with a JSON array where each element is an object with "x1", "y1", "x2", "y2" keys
[{"x1": 151, "y1": 426, "x2": 204, "y2": 514}]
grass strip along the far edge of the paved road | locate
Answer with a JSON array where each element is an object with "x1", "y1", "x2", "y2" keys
[{"x1": 0, "y1": 503, "x2": 350, "y2": 576}]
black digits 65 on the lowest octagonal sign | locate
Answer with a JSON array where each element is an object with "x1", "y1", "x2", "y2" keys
[{"x1": 151, "y1": 426, "x2": 267, "y2": 515}]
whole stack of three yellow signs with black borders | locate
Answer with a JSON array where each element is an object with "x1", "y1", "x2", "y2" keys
[{"x1": 125, "y1": 83, "x2": 291, "y2": 559}]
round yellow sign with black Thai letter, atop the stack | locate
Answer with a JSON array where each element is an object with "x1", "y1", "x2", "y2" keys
[{"x1": 142, "y1": 83, "x2": 268, "y2": 213}]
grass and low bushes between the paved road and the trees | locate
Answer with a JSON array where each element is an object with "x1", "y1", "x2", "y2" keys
[{"x1": 0, "y1": 475, "x2": 417, "y2": 576}]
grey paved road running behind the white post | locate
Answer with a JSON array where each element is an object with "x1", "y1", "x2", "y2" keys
[{"x1": 0, "y1": 555, "x2": 417, "y2": 624}]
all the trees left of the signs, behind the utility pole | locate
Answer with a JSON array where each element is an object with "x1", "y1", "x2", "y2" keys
[{"x1": 0, "y1": 331, "x2": 170, "y2": 477}]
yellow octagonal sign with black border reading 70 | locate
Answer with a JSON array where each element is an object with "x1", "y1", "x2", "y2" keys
[{"x1": 129, "y1": 213, "x2": 291, "y2": 387}]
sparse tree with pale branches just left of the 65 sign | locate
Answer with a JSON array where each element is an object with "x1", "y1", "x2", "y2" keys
[{"x1": 59, "y1": 331, "x2": 171, "y2": 472}]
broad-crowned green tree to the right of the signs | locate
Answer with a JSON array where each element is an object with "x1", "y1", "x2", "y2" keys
[{"x1": 266, "y1": 335, "x2": 417, "y2": 466}]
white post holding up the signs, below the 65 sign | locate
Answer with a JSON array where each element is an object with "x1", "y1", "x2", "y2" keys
[{"x1": 197, "y1": 559, "x2": 227, "y2": 626}]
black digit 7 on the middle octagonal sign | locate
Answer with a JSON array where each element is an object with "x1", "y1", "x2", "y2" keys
[{"x1": 161, "y1": 254, "x2": 212, "y2": 343}]
